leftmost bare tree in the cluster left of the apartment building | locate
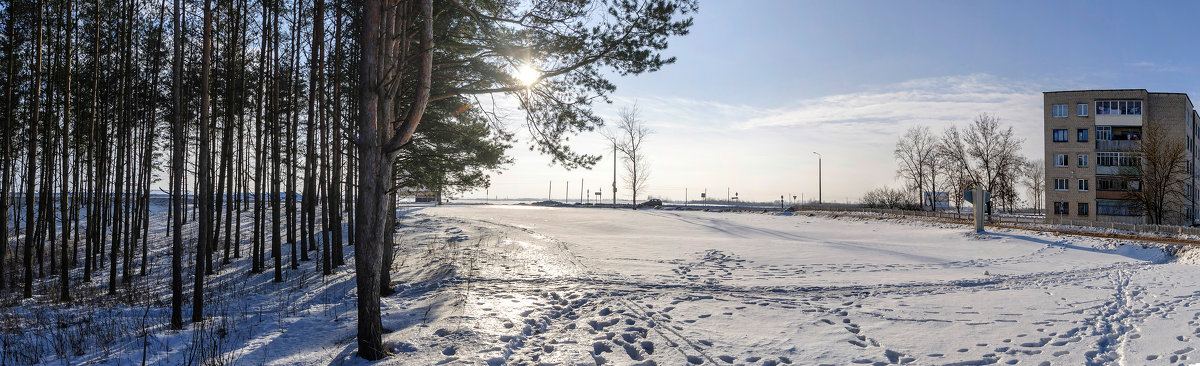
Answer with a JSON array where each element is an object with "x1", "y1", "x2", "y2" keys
[{"x1": 893, "y1": 126, "x2": 938, "y2": 210}]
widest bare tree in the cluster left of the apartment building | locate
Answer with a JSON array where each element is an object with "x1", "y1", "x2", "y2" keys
[{"x1": 941, "y1": 113, "x2": 1024, "y2": 215}]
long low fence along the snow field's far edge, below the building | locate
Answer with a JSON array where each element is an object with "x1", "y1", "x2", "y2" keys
[{"x1": 793, "y1": 205, "x2": 1200, "y2": 236}]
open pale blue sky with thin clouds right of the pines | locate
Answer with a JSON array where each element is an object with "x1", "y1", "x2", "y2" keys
[{"x1": 462, "y1": 1, "x2": 1200, "y2": 202}]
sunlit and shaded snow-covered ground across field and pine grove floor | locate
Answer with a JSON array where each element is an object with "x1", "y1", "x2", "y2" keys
[{"x1": 8, "y1": 205, "x2": 1200, "y2": 365}]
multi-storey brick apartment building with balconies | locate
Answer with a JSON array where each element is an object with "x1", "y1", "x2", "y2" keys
[{"x1": 1043, "y1": 89, "x2": 1200, "y2": 224}]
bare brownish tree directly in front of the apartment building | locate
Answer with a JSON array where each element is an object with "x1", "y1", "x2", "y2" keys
[{"x1": 1118, "y1": 121, "x2": 1190, "y2": 224}]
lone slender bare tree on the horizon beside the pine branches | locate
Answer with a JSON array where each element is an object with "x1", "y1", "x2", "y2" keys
[{"x1": 607, "y1": 104, "x2": 653, "y2": 210}]
